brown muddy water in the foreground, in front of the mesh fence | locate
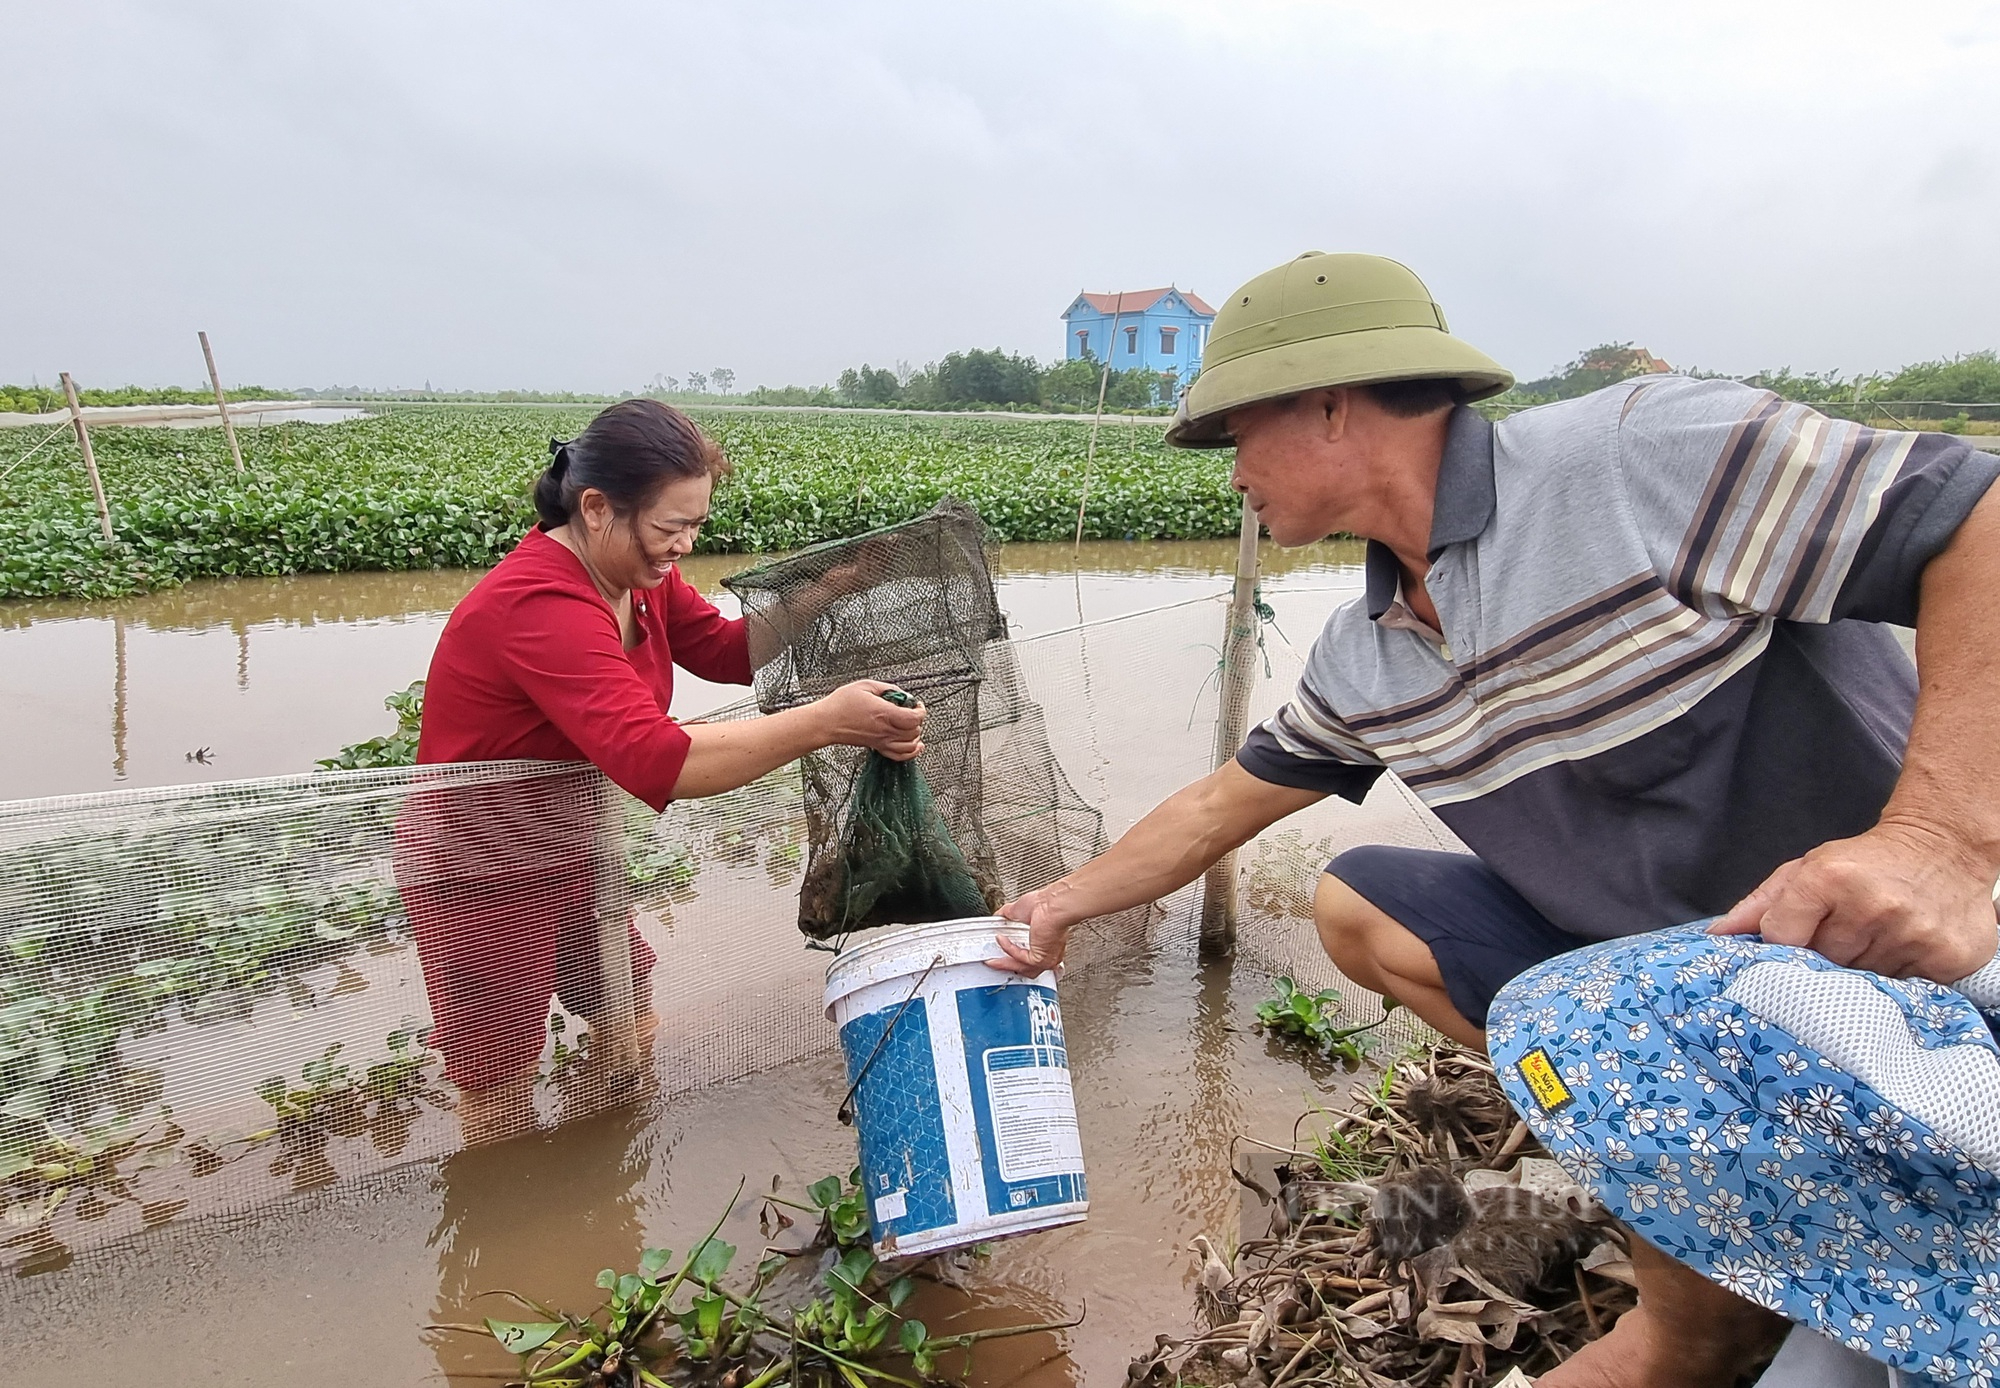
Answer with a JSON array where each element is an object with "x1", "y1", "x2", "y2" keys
[{"x1": 0, "y1": 952, "x2": 1346, "y2": 1388}]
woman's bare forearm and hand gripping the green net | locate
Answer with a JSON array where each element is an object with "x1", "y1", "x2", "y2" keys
[{"x1": 674, "y1": 680, "x2": 924, "y2": 800}]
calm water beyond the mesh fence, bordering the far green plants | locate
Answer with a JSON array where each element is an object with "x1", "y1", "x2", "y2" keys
[{"x1": 0, "y1": 540, "x2": 1360, "y2": 800}]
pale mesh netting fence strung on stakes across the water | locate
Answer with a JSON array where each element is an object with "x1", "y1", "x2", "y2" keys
[{"x1": 0, "y1": 590, "x2": 1450, "y2": 1270}]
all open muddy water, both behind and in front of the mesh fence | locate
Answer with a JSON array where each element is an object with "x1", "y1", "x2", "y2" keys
[{"x1": 0, "y1": 542, "x2": 1412, "y2": 1388}]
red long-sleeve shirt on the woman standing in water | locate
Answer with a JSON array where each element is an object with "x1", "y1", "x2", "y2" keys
[{"x1": 416, "y1": 530, "x2": 750, "y2": 810}]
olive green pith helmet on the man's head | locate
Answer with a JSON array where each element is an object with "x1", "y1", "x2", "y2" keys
[{"x1": 1166, "y1": 250, "x2": 1514, "y2": 448}]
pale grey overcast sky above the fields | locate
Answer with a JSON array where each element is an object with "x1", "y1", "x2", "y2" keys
[{"x1": 0, "y1": 0, "x2": 2000, "y2": 390}]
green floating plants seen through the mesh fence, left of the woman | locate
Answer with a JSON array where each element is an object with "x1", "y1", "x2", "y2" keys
[{"x1": 0, "y1": 790, "x2": 408, "y2": 1128}]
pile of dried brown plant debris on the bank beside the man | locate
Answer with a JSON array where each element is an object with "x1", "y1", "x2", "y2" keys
[{"x1": 1130, "y1": 1044, "x2": 1634, "y2": 1388}]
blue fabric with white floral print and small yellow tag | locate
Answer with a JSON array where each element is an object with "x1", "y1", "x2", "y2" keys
[{"x1": 1488, "y1": 922, "x2": 2000, "y2": 1388}]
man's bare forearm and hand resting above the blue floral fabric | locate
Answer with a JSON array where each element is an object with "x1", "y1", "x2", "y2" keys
[{"x1": 1714, "y1": 484, "x2": 2000, "y2": 984}]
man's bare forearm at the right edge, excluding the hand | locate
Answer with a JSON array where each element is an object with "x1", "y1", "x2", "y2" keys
[{"x1": 1882, "y1": 486, "x2": 2000, "y2": 876}]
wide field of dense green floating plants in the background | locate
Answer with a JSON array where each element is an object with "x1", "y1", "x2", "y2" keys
[{"x1": 0, "y1": 406, "x2": 1242, "y2": 598}]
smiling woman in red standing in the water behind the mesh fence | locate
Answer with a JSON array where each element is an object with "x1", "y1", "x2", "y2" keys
[{"x1": 396, "y1": 400, "x2": 924, "y2": 1142}]
